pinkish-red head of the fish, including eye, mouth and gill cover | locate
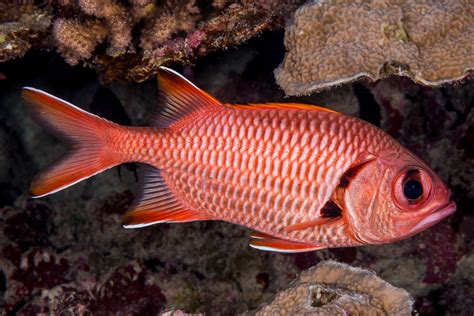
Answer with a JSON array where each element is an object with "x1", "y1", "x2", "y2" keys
[{"x1": 343, "y1": 149, "x2": 456, "y2": 244}]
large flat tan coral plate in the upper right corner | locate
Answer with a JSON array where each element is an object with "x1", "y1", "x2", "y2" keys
[{"x1": 275, "y1": 0, "x2": 474, "y2": 95}]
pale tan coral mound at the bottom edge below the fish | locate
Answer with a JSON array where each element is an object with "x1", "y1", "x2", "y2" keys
[{"x1": 256, "y1": 261, "x2": 414, "y2": 316}]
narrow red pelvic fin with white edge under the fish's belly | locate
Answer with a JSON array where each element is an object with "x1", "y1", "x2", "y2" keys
[{"x1": 250, "y1": 232, "x2": 326, "y2": 253}]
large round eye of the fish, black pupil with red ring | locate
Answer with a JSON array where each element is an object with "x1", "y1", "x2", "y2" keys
[{"x1": 393, "y1": 167, "x2": 432, "y2": 211}]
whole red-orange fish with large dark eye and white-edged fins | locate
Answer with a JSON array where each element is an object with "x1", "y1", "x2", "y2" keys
[{"x1": 22, "y1": 67, "x2": 456, "y2": 253}]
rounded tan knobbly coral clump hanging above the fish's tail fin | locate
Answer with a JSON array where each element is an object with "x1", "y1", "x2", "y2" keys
[{"x1": 53, "y1": 19, "x2": 107, "y2": 65}]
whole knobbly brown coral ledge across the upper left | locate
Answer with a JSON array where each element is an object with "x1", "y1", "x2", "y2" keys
[{"x1": 0, "y1": 0, "x2": 303, "y2": 82}]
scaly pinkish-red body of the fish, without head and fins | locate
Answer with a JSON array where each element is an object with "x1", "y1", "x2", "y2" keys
[{"x1": 115, "y1": 107, "x2": 392, "y2": 242}]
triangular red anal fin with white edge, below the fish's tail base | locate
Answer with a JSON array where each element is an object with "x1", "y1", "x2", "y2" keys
[{"x1": 123, "y1": 166, "x2": 210, "y2": 228}]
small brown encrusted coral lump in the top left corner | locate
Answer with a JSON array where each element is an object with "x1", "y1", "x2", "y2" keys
[{"x1": 0, "y1": 1, "x2": 52, "y2": 62}]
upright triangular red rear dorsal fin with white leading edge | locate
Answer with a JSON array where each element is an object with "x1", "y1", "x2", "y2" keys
[{"x1": 153, "y1": 67, "x2": 222, "y2": 127}]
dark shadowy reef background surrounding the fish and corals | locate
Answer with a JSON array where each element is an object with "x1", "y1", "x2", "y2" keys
[{"x1": 0, "y1": 1, "x2": 474, "y2": 315}]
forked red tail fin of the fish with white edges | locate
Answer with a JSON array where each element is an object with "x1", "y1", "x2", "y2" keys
[{"x1": 22, "y1": 88, "x2": 120, "y2": 198}]
